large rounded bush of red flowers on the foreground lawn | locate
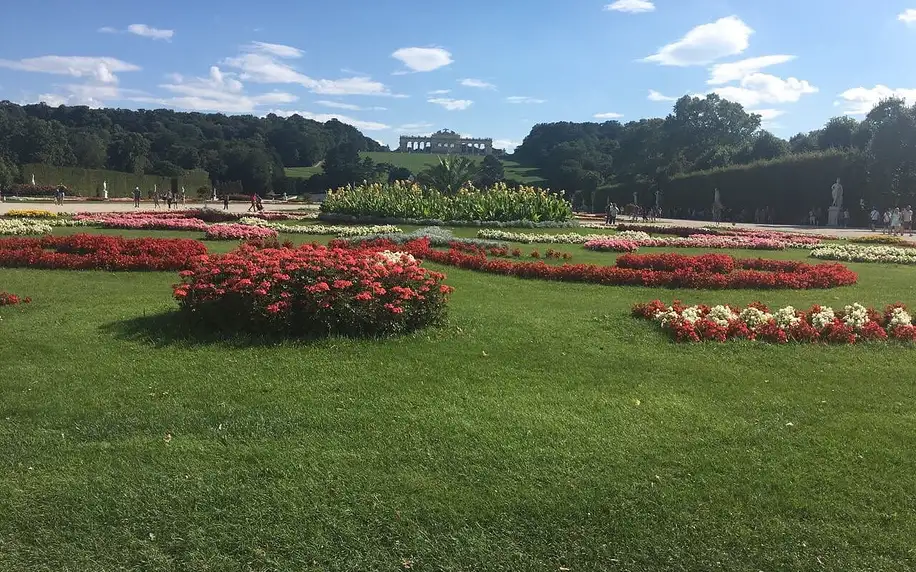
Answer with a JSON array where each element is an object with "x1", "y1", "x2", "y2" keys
[{"x1": 174, "y1": 240, "x2": 451, "y2": 336}]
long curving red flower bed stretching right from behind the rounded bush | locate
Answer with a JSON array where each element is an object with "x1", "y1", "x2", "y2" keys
[{"x1": 331, "y1": 239, "x2": 858, "y2": 289}]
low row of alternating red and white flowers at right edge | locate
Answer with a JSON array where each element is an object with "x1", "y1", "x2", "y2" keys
[{"x1": 633, "y1": 300, "x2": 916, "y2": 344}]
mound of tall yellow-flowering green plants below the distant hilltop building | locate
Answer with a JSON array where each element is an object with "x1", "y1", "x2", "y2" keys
[{"x1": 321, "y1": 181, "x2": 573, "y2": 222}]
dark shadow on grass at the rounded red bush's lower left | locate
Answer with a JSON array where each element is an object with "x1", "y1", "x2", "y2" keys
[{"x1": 99, "y1": 311, "x2": 304, "y2": 348}]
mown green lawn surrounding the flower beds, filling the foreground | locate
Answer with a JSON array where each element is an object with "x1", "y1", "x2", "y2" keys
[{"x1": 0, "y1": 229, "x2": 916, "y2": 572}]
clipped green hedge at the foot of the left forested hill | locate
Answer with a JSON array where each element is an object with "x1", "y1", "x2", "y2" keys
[{"x1": 20, "y1": 163, "x2": 210, "y2": 199}]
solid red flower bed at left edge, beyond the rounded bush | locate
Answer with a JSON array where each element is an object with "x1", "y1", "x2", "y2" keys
[{"x1": 0, "y1": 234, "x2": 207, "y2": 270}]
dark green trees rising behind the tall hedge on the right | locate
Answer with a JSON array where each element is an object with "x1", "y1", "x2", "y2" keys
[{"x1": 514, "y1": 94, "x2": 916, "y2": 201}]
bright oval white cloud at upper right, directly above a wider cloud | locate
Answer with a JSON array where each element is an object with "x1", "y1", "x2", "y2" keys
[{"x1": 644, "y1": 16, "x2": 754, "y2": 66}]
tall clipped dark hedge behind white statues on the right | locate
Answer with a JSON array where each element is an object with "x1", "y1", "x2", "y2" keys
[{"x1": 592, "y1": 151, "x2": 864, "y2": 224}]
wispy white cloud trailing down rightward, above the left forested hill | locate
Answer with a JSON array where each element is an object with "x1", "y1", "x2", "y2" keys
[{"x1": 222, "y1": 42, "x2": 400, "y2": 97}]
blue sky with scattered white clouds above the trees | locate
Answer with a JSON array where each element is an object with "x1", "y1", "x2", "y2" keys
[{"x1": 0, "y1": 0, "x2": 916, "y2": 150}]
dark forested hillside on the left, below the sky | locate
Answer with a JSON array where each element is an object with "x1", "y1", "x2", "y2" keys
[{"x1": 0, "y1": 101, "x2": 381, "y2": 191}]
